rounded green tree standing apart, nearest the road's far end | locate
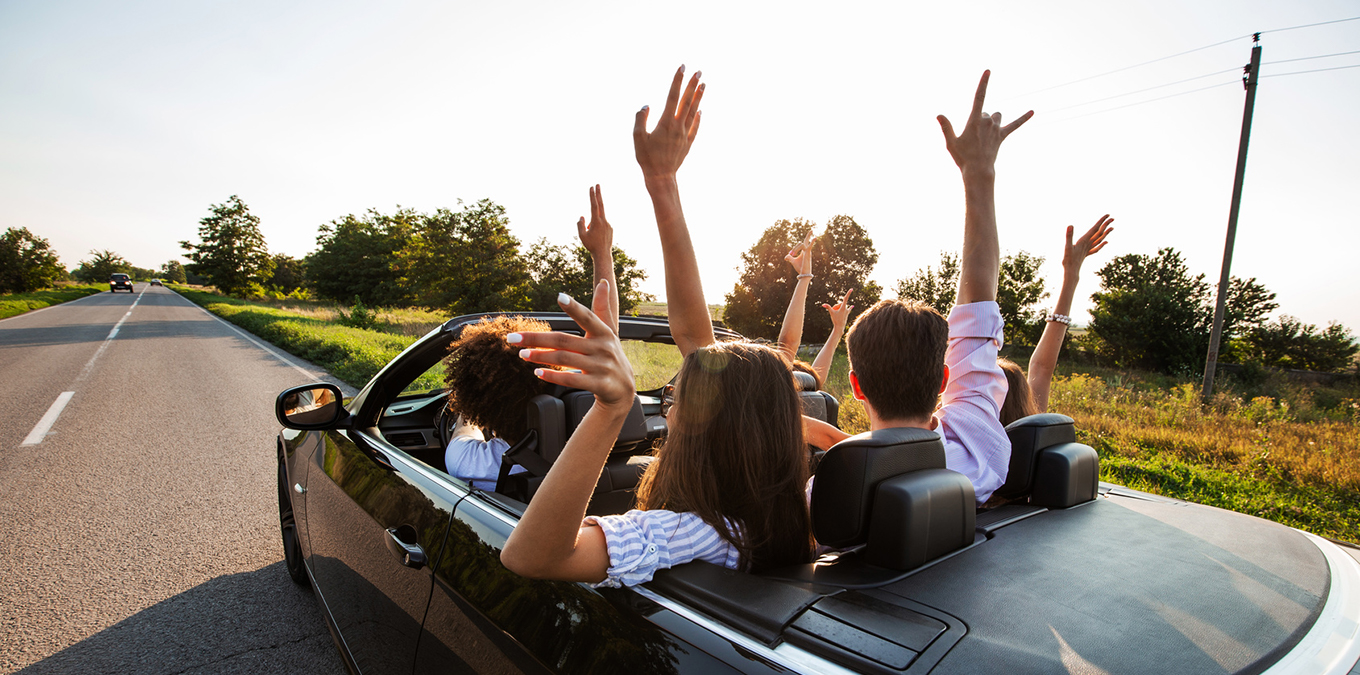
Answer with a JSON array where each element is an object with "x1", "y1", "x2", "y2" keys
[{"x1": 180, "y1": 195, "x2": 273, "y2": 295}]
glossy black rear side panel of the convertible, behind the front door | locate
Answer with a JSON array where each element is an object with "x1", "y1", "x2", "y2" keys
[{"x1": 415, "y1": 491, "x2": 756, "y2": 675}]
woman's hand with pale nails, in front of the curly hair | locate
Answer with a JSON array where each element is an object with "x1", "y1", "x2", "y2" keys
[{"x1": 506, "y1": 276, "x2": 634, "y2": 414}]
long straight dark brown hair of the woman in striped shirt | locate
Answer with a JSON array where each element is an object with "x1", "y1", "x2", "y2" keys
[{"x1": 638, "y1": 342, "x2": 813, "y2": 572}]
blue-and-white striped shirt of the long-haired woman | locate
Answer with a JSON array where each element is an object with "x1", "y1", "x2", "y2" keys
[{"x1": 582, "y1": 509, "x2": 740, "y2": 588}]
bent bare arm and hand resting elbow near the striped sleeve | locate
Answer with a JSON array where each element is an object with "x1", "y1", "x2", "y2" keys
[{"x1": 500, "y1": 282, "x2": 634, "y2": 581}]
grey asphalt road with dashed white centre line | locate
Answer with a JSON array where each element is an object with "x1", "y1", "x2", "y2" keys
[{"x1": 0, "y1": 284, "x2": 350, "y2": 675}]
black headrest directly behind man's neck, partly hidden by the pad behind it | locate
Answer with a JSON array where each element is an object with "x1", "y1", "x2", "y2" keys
[{"x1": 812, "y1": 427, "x2": 945, "y2": 548}]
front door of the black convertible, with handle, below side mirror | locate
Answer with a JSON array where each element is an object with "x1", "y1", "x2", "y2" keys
[{"x1": 306, "y1": 430, "x2": 458, "y2": 675}]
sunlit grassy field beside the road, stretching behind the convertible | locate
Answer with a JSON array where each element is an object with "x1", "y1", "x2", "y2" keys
[{"x1": 172, "y1": 289, "x2": 1360, "y2": 542}]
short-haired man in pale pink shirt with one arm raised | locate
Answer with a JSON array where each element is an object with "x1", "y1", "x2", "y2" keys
[{"x1": 805, "y1": 71, "x2": 1034, "y2": 504}]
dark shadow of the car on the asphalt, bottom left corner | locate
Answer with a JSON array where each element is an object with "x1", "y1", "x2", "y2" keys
[{"x1": 18, "y1": 562, "x2": 344, "y2": 675}]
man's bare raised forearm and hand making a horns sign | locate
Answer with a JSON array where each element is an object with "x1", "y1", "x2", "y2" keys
[{"x1": 937, "y1": 71, "x2": 1034, "y2": 305}]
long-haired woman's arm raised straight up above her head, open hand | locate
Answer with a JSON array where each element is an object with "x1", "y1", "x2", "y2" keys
[{"x1": 632, "y1": 65, "x2": 714, "y2": 355}]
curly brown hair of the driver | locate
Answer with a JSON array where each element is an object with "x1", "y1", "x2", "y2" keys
[{"x1": 443, "y1": 316, "x2": 552, "y2": 444}]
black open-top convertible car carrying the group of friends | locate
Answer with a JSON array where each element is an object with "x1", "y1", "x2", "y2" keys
[{"x1": 276, "y1": 314, "x2": 1360, "y2": 675}]
